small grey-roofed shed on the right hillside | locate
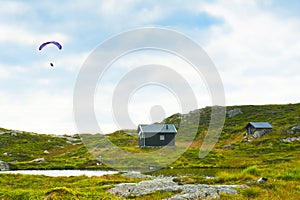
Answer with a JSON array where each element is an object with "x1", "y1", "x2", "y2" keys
[{"x1": 246, "y1": 122, "x2": 273, "y2": 137}]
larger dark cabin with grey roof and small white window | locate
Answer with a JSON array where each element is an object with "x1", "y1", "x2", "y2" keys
[{"x1": 137, "y1": 124, "x2": 177, "y2": 147}]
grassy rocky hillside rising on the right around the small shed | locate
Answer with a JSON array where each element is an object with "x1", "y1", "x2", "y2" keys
[{"x1": 165, "y1": 104, "x2": 300, "y2": 167}]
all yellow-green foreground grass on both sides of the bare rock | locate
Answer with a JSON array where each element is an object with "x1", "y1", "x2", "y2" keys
[{"x1": 0, "y1": 161, "x2": 300, "y2": 200}]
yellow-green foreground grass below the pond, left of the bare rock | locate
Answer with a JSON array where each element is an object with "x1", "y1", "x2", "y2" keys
[{"x1": 0, "y1": 174, "x2": 139, "y2": 200}]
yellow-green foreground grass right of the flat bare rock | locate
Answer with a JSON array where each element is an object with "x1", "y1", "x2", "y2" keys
[{"x1": 171, "y1": 160, "x2": 300, "y2": 199}]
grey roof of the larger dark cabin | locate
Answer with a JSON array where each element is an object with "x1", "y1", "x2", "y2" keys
[{"x1": 139, "y1": 124, "x2": 177, "y2": 133}]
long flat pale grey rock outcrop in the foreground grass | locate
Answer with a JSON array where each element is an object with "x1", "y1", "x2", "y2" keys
[{"x1": 108, "y1": 177, "x2": 246, "y2": 200}]
